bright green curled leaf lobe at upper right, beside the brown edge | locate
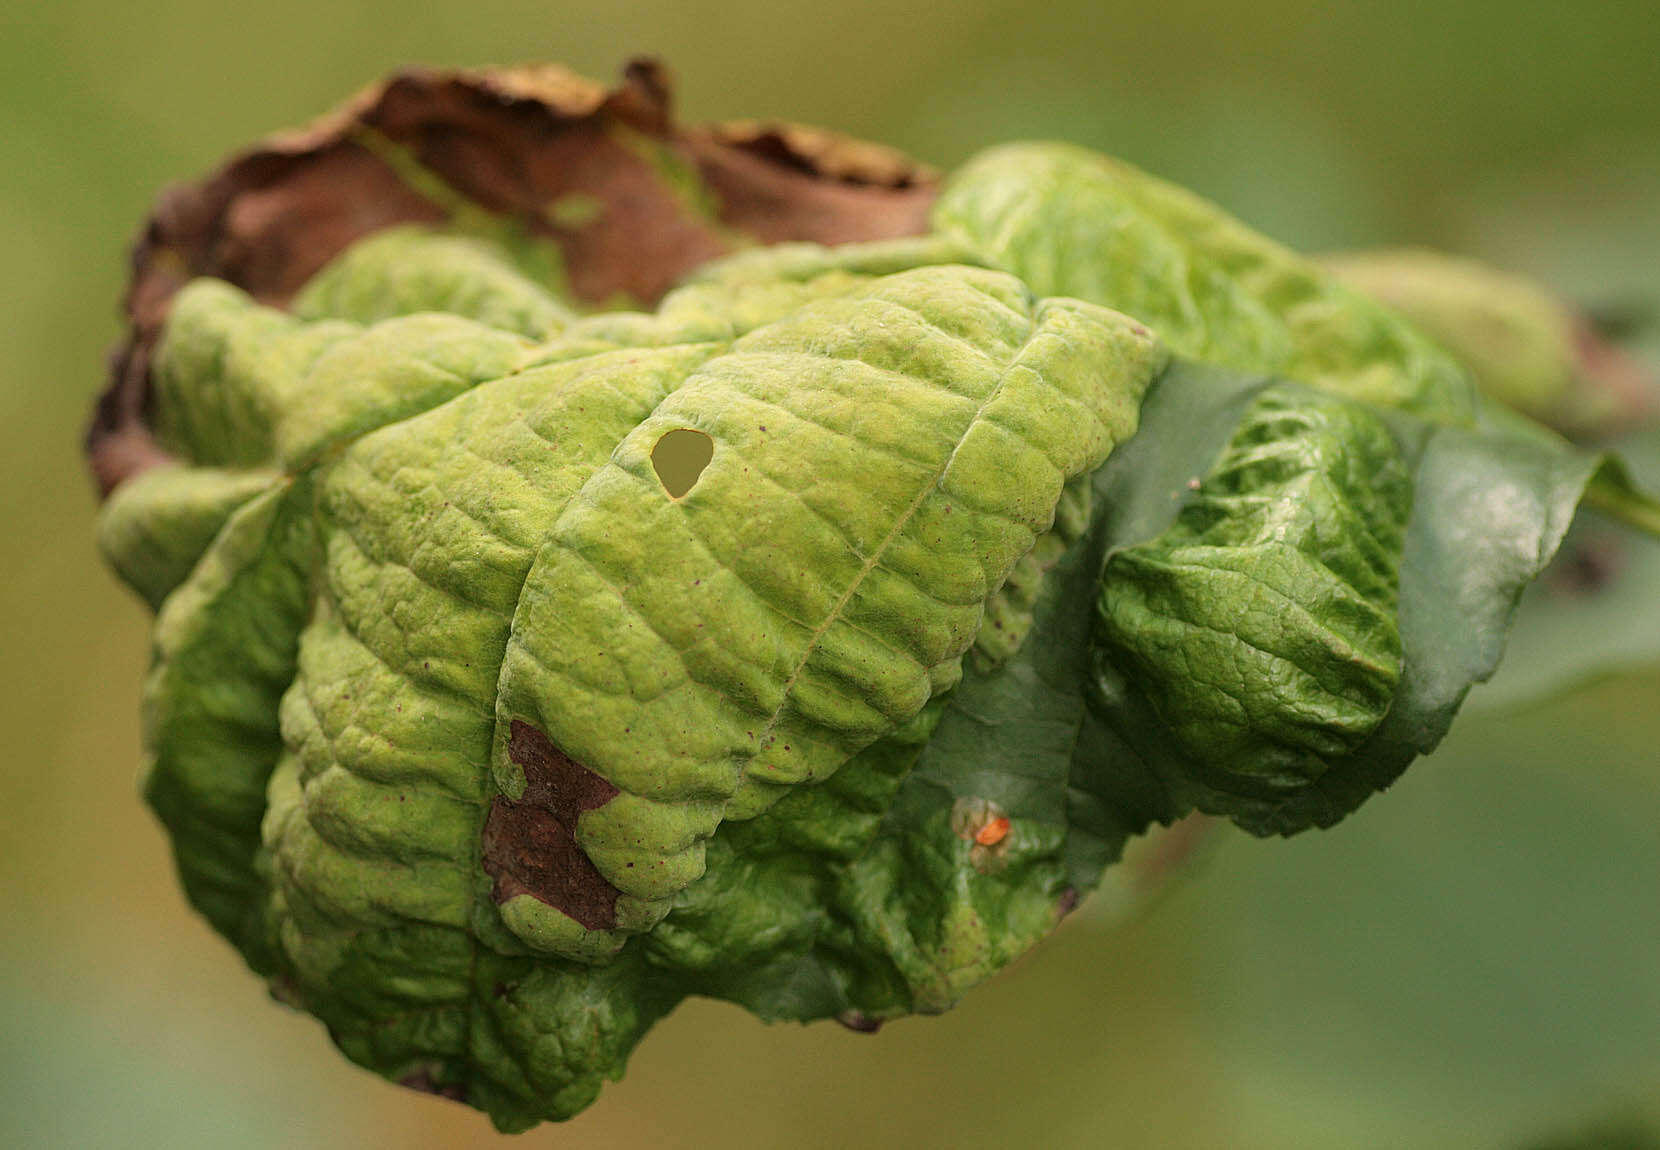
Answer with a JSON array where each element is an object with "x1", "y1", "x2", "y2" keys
[{"x1": 933, "y1": 143, "x2": 1472, "y2": 422}]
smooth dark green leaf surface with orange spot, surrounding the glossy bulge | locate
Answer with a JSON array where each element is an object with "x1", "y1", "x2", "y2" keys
[{"x1": 700, "y1": 363, "x2": 1633, "y2": 1021}]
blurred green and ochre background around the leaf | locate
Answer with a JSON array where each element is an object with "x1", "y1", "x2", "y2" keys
[{"x1": 0, "y1": 0, "x2": 1660, "y2": 1150}]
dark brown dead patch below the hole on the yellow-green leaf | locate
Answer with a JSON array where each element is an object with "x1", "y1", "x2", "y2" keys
[{"x1": 483, "y1": 719, "x2": 618, "y2": 931}]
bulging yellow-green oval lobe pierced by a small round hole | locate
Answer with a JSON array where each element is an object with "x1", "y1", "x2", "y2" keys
[{"x1": 496, "y1": 267, "x2": 1162, "y2": 946}]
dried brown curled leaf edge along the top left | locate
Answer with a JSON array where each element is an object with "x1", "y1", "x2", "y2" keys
[{"x1": 86, "y1": 58, "x2": 938, "y2": 496}]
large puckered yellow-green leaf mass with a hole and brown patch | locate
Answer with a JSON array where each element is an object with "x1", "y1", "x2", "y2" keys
[{"x1": 158, "y1": 257, "x2": 1164, "y2": 1127}]
